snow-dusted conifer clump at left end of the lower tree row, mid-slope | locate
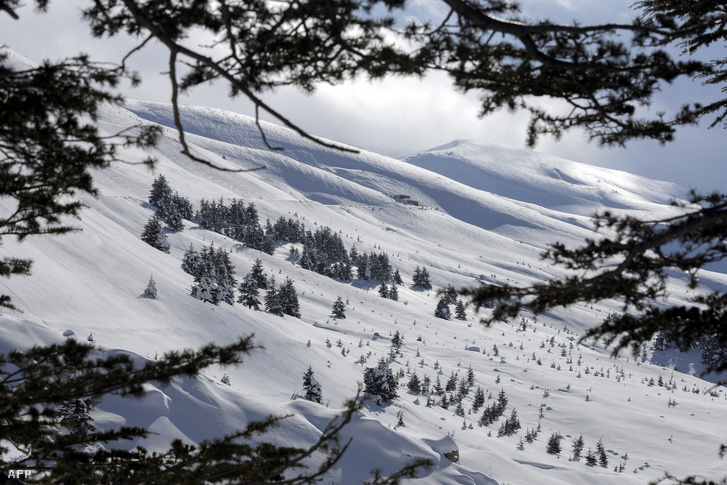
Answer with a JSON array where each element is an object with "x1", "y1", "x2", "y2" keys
[{"x1": 182, "y1": 244, "x2": 237, "y2": 305}]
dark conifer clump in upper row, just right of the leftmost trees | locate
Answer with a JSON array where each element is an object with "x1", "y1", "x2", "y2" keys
[{"x1": 196, "y1": 198, "x2": 275, "y2": 254}]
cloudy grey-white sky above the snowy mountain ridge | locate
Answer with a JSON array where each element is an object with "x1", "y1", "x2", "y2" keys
[{"x1": 5, "y1": 0, "x2": 727, "y2": 191}]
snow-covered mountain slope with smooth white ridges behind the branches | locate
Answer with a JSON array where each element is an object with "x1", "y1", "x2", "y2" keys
[{"x1": 0, "y1": 50, "x2": 727, "y2": 485}]
